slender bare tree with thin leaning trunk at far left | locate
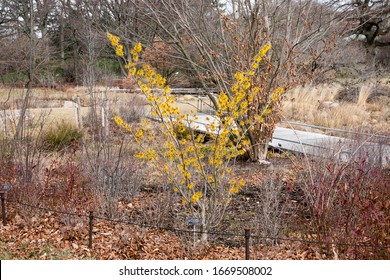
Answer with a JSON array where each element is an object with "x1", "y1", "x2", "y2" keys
[{"x1": 1, "y1": 0, "x2": 53, "y2": 185}]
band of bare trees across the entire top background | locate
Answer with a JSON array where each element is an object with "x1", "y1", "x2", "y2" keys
[{"x1": 0, "y1": 0, "x2": 390, "y2": 87}]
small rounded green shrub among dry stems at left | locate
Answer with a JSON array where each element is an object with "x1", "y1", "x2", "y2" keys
[{"x1": 42, "y1": 122, "x2": 83, "y2": 151}]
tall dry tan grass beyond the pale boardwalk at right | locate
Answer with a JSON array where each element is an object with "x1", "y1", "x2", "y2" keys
[{"x1": 282, "y1": 83, "x2": 390, "y2": 133}]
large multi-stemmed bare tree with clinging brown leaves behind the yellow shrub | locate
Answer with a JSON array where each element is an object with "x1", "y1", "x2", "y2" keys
[{"x1": 133, "y1": 0, "x2": 336, "y2": 161}]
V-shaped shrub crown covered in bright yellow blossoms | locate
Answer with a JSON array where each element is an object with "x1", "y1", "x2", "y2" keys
[{"x1": 107, "y1": 33, "x2": 284, "y2": 224}]
